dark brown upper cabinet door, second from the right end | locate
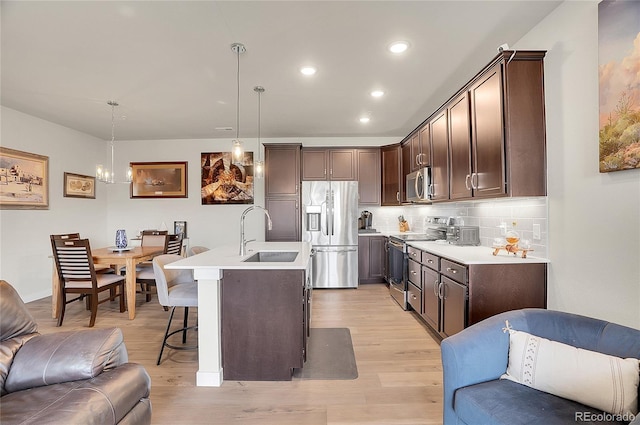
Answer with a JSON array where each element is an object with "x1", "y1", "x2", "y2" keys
[{"x1": 448, "y1": 92, "x2": 471, "y2": 199}]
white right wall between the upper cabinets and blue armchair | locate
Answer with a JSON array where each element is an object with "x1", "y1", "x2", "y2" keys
[{"x1": 515, "y1": 1, "x2": 640, "y2": 328}]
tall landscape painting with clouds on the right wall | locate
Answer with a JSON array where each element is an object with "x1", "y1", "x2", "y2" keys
[{"x1": 598, "y1": 0, "x2": 640, "y2": 173}]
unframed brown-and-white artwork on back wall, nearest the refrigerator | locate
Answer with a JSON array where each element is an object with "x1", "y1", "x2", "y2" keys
[{"x1": 200, "y1": 152, "x2": 253, "y2": 205}]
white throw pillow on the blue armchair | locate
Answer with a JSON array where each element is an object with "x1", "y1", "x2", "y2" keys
[{"x1": 500, "y1": 323, "x2": 640, "y2": 416}]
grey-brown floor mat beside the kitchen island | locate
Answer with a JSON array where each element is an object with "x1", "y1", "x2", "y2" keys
[{"x1": 293, "y1": 328, "x2": 358, "y2": 380}]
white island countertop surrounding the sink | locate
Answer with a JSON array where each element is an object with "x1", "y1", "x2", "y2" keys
[{"x1": 166, "y1": 242, "x2": 311, "y2": 270}]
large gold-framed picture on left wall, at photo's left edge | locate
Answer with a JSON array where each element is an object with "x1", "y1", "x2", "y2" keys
[{"x1": 0, "y1": 146, "x2": 49, "y2": 209}]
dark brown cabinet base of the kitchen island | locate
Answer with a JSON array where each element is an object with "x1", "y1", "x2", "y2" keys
[{"x1": 220, "y1": 270, "x2": 310, "y2": 381}]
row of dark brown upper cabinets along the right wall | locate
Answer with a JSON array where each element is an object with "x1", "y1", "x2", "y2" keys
[{"x1": 383, "y1": 51, "x2": 547, "y2": 205}]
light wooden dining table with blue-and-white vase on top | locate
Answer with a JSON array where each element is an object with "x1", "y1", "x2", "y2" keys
[{"x1": 51, "y1": 246, "x2": 164, "y2": 319}]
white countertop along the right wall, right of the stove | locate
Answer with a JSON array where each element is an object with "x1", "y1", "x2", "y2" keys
[{"x1": 407, "y1": 241, "x2": 549, "y2": 264}]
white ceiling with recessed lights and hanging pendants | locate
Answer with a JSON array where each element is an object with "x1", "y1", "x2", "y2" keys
[{"x1": 0, "y1": 0, "x2": 561, "y2": 140}]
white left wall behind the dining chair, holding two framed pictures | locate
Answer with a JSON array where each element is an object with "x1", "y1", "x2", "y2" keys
[{"x1": 0, "y1": 107, "x2": 107, "y2": 301}]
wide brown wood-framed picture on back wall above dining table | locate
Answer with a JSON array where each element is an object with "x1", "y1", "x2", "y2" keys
[{"x1": 129, "y1": 161, "x2": 187, "y2": 198}]
